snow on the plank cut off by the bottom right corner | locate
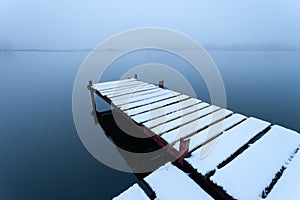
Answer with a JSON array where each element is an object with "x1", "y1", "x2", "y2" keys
[{"x1": 266, "y1": 148, "x2": 300, "y2": 200}]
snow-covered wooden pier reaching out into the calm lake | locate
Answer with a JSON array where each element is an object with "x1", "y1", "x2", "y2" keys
[{"x1": 89, "y1": 77, "x2": 300, "y2": 199}]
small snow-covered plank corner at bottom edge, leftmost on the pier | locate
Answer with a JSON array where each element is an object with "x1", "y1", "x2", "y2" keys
[{"x1": 113, "y1": 183, "x2": 150, "y2": 200}]
